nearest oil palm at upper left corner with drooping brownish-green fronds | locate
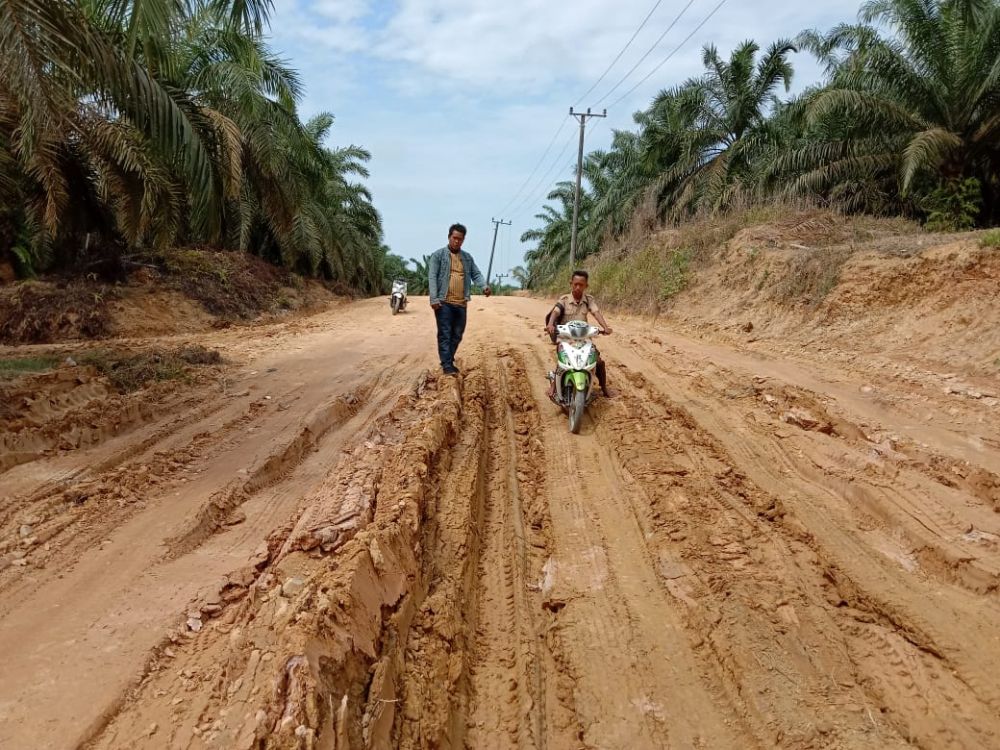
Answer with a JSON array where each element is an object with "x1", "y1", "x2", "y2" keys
[{"x1": 0, "y1": 0, "x2": 215, "y2": 256}]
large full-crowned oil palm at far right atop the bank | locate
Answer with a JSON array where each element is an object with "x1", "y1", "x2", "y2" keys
[{"x1": 783, "y1": 0, "x2": 1000, "y2": 221}]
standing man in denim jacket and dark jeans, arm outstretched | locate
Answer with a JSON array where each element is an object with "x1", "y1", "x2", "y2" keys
[{"x1": 427, "y1": 224, "x2": 490, "y2": 375}]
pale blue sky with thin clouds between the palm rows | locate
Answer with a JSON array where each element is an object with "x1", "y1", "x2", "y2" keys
[{"x1": 271, "y1": 0, "x2": 858, "y2": 282}]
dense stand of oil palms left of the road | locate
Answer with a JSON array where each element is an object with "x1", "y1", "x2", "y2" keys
[{"x1": 0, "y1": 0, "x2": 387, "y2": 293}]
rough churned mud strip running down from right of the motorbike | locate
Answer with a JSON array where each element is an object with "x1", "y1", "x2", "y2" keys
[{"x1": 599, "y1": 374, "x2": 907, "y2": 747}]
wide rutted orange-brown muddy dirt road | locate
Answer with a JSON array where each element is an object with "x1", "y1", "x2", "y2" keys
[{"x1": 0, "y1": 298, "x2": 1000, "y2": 750}]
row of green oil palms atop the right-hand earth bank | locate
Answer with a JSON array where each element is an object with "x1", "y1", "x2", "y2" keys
[{"x1": 521, "y1": 0, "x2": 1000, "y2": 288}]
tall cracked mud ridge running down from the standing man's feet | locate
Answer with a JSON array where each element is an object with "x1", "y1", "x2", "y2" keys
[{"x1": 93, "y1": 374, "x2": 470, "y2": 748}]
